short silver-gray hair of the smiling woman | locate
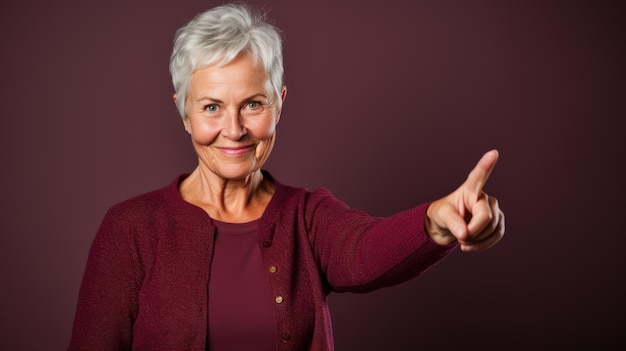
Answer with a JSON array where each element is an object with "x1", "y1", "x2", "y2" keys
[{"x1": 170, "y1": 4, "x2": 284, "y2": 118}]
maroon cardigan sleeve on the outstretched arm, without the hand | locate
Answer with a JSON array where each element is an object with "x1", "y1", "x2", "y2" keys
[{"x1": 306, "y1": 189, "x2": 457, "y2": 292}]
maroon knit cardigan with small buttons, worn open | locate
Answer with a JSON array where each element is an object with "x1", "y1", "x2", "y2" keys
[{"x1": 68, "y1": 173, "x2": 456, "y2": 351}]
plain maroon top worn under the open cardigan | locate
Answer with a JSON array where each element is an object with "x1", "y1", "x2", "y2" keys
[{"x1": 208, "y1": 220, "x2": 276, "y2": 351}]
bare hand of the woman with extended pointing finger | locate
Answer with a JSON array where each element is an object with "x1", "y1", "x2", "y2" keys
[{"x1": 425, "y1": 150, "x2": 504, "y2": 251}]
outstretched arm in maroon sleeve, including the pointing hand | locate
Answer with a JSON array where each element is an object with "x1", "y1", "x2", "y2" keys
[{"x1": 308, "y1": 150, "x2": 504, "y2": 292}]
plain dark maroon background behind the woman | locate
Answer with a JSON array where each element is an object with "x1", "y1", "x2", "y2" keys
[{"x1": 0, "y1": 0, "x2": 626, "y2": 350}]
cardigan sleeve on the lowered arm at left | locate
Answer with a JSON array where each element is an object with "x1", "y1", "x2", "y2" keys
[{"x1": 68, "y1": 207, "x2": 139, "y2": 350}]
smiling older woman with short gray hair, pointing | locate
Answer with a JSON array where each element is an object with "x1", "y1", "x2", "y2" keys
[{"x1": 69, "y1": 5, "x2": 504, "y2": 350}]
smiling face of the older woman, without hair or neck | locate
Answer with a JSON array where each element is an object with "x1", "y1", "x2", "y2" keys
[{"x1": 174, "y1": 55, "x2": 286, "y2": 184}]
